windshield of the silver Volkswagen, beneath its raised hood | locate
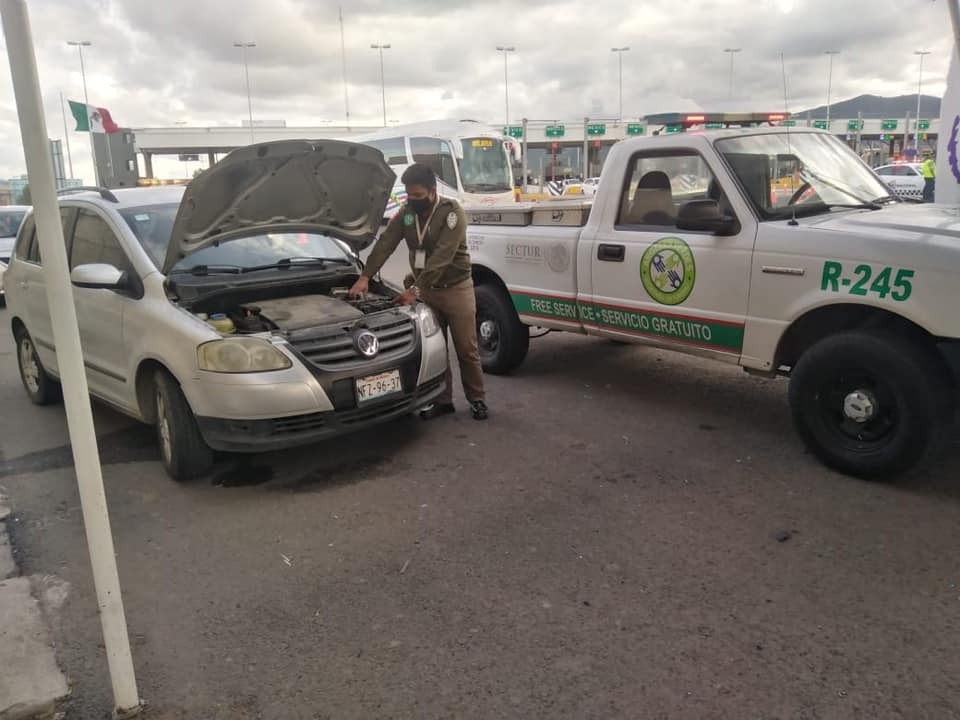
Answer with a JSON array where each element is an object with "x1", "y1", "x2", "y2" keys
[{"x1": 170, "y1": 233, "x2": 350, "y2": 274}]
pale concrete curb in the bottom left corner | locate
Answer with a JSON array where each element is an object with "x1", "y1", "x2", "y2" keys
[{"x1": 0, "y1": 497, "x2": 70, "y2": 720}]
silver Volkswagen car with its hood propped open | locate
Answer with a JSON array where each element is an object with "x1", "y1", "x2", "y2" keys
[{"x1": 6, "y1": 141, "x2": 447, "y2": 480}]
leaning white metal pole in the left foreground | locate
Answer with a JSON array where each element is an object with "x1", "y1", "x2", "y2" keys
[{"x1": 0, "y1": 0, "x2": 140, "y2": 717}]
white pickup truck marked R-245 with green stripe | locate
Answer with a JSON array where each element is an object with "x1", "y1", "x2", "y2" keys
[{"x1": 468, "y1": 127, "x2": 960, "y2": 478}]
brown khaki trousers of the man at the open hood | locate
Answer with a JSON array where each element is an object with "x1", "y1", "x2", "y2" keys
[{"x1": 421, "y1": 278, "x2": 486, "y2": 403}]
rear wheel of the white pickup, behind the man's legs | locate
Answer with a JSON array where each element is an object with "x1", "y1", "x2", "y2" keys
[{"x1": 474, "y1": 284, "x2": 530, "y2": 375}]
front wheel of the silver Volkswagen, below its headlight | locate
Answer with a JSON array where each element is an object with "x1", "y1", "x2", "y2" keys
[{"x1": 153, "y1": 370, "x2": 213, "y2": 482}]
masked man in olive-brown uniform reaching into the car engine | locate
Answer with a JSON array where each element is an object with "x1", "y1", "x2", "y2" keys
[{"x1": 350, "y1": 163, "x2": 488, "y2": 420}]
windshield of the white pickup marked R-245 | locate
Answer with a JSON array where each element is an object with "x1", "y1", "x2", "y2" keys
[{"x1": 716, "y1": 132, "x2": 890, "y2": 220}]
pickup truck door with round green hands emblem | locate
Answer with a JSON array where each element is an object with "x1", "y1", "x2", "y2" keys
[{"x1": 580, "y1": 147, "x2": 757, "y2": 362}]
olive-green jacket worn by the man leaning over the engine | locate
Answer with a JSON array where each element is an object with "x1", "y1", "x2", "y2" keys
[{"x1": 363, "y1": 197, "x2": 471, "y2": 290}]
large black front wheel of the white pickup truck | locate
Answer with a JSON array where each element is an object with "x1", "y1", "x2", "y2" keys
[{"x1": 789, "y1": 331, "x2": 952, "y2": 480}]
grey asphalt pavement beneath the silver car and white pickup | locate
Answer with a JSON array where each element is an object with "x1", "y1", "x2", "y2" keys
[{"x1": 0, "y1": 266, "x2": 960, "y2": 720}]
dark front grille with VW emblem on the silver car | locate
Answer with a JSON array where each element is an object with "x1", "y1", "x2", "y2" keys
[{"x1": 290, "y1": 313, "x2": 416, "y2": 369}]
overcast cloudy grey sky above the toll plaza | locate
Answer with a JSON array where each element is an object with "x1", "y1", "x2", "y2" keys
[{"x1": 0, "y1": 0, "x2": 951, "y2": 180}]
